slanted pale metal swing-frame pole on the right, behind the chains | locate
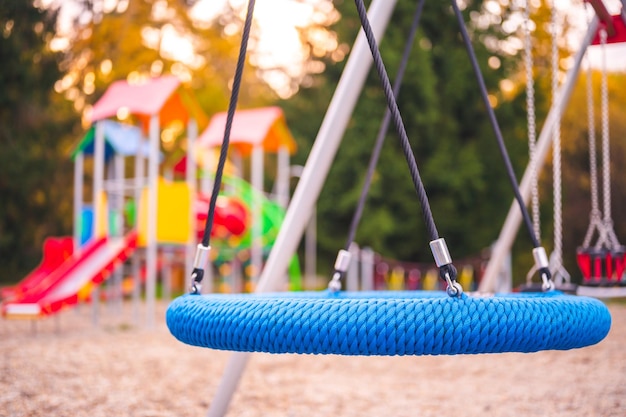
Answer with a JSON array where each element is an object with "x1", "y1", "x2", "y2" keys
[{"x1": 479, "y1": 16, "x2": 598, "y2": 292}]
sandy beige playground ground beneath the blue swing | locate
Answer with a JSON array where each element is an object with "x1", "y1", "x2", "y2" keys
[{"x1": 0, "y1": 303, "x2": 626, "y2": 417}]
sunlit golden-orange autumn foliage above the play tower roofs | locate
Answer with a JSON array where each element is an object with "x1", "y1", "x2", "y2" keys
[{"x1": 58, "y1": 0, "x2": 275, "y2": 127}]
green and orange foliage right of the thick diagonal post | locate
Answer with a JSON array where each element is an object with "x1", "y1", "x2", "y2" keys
[{"x1": 285, "y1": 1, "x2": 624, "y2": 281}]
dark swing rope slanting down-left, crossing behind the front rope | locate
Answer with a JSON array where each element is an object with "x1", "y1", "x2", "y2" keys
[{"x1": 328, "y1": 0, "x2": 425, "y2": 291}]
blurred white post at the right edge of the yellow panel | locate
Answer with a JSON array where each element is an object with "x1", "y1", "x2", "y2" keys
[{"x1": 185, "y1": 118, "x2": 198, "y2": 284}]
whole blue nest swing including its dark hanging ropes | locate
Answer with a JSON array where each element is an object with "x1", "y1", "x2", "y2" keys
[{"x1": 166, "y1": 0, "x2": 611, "y2": 356}]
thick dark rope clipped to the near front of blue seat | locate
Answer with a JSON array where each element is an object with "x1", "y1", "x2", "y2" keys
[{"x1": 354, "y1": 0, "x2": 462, "y2": 296}]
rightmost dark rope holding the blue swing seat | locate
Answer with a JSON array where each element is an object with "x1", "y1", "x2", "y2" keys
[{"x1": 452, "y1": 0, "x2": 552, "y2": 281}]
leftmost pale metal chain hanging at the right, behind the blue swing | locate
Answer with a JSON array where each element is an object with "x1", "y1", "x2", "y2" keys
[{"x1": 524, "y1": 0, "x2": 541, "y2": 240}]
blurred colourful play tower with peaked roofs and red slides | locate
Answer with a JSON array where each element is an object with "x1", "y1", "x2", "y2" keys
[{"x1": 0, "y1": 75, "x2": 296, "y2": 320}]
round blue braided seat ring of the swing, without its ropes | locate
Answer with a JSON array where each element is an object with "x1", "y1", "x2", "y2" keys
[{"x1": 166, "y1": 291, "x2": 611, "y2": 356}]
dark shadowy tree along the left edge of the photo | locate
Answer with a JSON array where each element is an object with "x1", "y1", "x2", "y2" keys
[{"x1": 0, "y1": 1, "x2": 78, "y2": 282}]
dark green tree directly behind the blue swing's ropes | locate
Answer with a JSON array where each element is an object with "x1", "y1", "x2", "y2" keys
[{"x1": 285, "y1": 1, "x2": 527, "y2": 276}]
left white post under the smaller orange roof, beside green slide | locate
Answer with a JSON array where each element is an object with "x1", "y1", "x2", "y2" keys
[{"x1": 250, "y1": 145, "x2": 264, "y2": 284}]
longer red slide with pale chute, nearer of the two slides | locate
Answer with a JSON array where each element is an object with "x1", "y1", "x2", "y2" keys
[{"x1": 2, "y1": 231, "x2": 137, "y2": 318}]
